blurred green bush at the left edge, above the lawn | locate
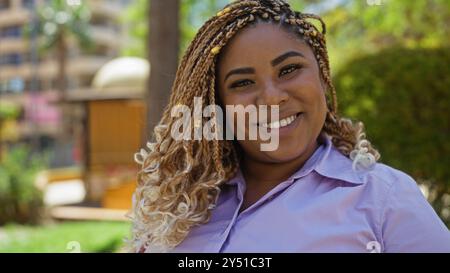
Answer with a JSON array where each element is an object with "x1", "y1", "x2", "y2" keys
[{"x1": 0, "y1": 146, "x2": 47, "y2": 225}]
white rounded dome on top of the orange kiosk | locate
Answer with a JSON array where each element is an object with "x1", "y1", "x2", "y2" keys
[{"x1": 92, "y1": 57, "x2": 150, "y2": 91}]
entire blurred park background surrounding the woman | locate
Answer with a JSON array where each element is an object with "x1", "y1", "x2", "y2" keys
[{"x1": 0, "y1": 0, "x2": 450, "y2": 252}]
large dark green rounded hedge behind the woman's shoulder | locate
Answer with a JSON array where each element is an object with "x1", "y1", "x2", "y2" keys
[{"x1": 334, "y1": 47, "x2": 450, "y2": 221}]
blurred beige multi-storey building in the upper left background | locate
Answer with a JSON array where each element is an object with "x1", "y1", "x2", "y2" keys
[{"x1": 0, "y1": 0, "x2": 130, "y2": 168}]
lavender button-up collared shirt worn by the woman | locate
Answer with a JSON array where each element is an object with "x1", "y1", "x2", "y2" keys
[{"x1": 173, "y1": 139, "x2": 450, "y2": 252}]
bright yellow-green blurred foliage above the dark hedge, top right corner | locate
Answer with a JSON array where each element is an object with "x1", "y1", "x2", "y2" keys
[{"x1": 322, "y1": 0, "x2": 450, "y2": 70}]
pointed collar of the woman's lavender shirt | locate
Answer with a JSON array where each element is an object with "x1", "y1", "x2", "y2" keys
[{"x1": 225, "y1": 134, "x2": 363, "y2": 185}]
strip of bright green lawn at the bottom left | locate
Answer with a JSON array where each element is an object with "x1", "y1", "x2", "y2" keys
[{"x1": 0, "y1": 221, "x2": 130, "y2": 253}]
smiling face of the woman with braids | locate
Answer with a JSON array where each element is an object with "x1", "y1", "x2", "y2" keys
[{"x1": 217, "y1": 23, "x2": 327, "y2": 163}]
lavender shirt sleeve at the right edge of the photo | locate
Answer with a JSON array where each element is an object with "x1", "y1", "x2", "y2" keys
[{"x1": 382, "y1": 172, "x2": 450, "y2": 252}]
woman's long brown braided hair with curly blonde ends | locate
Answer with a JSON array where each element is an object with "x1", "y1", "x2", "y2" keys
[{"x1": 129, "y1": 0, "x2": 379, "y2": 252}]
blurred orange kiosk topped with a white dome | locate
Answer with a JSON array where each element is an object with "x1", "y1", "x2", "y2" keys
[{"x1": 66, "y1": 57, "x2": 150, "y2": 209}]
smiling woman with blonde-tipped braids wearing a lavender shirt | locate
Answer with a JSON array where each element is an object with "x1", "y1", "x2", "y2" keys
[{"x1": 130, "y1": 0, "x2": 450, "y2": 252}]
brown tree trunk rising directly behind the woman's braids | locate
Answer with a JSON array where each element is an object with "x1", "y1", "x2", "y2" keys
[{"x1": 145, "y1": 0, "x2": 180, "y2": 139}]
